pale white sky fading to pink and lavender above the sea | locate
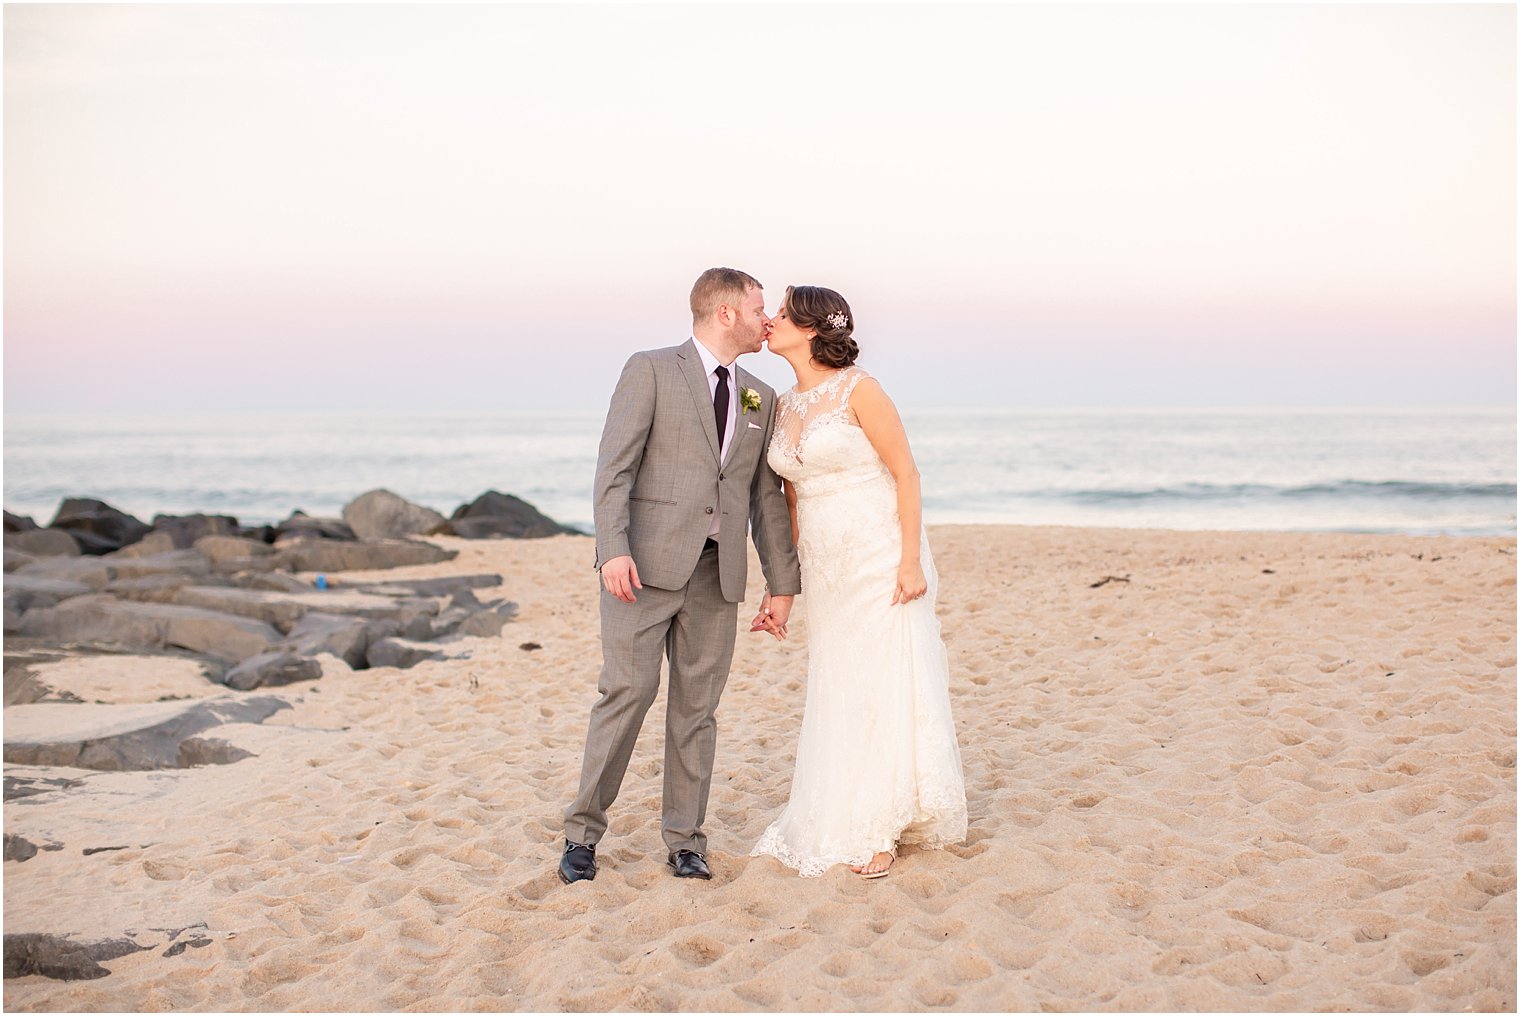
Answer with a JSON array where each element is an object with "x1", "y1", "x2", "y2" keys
[{"x1": 5, "y1": 5, "x2": 1515, "y2": 412}]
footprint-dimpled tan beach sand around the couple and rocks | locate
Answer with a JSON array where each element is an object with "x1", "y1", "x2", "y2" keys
[{"x1": 5, "y1": 526, "x2": 1515, "y2": 1010}]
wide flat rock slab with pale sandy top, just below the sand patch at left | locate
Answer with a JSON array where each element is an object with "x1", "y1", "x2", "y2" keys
[{"x1": 5, "y1": 695, "x2": 290, "y2": 771}]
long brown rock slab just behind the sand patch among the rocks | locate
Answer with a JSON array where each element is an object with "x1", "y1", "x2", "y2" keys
[{"x1": 21, "y1": 595, "x2": 280, "y2": 663}]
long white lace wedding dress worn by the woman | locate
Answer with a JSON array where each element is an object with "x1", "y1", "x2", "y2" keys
[{"x1": 751, "y1": 367, "x2": 965, "y2": 876}]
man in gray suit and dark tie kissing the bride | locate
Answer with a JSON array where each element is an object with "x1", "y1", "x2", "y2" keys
[{"x1": 559, "y1": 268, "x2": 801, "y2": 882}]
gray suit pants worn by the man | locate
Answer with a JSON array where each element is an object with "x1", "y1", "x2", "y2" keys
[{"x1": 565, "y1": 546, "x2": 739, "y2": 853}]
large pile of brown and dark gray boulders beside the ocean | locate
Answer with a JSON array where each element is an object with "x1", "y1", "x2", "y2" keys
[{"x1": 5, "y1": 490, "x2": 575, "y2": 691}]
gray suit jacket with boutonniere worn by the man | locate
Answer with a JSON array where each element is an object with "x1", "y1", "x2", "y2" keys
[{"x1": 593, "y1": 339, "x2": 803, "y2": 602}]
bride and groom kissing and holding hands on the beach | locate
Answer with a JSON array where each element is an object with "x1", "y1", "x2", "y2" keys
[{"x1": 559, "y1": 268, "x2": 967, "y2": 884}]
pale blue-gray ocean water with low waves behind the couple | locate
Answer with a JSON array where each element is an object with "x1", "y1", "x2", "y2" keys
[{"x1": 5, "y1": 408, "x2": 1515, "y2": 535}]
